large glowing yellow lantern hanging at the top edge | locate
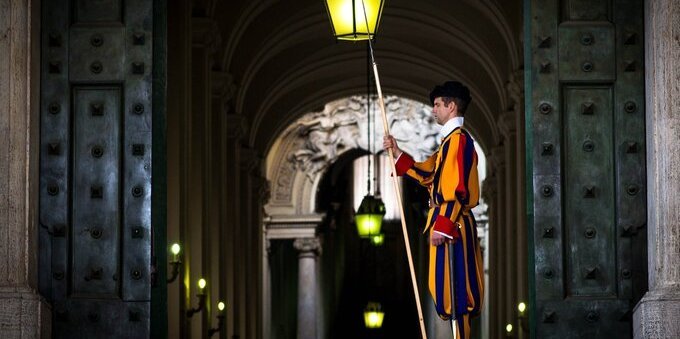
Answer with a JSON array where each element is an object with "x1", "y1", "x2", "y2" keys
[{"x1": 326, "y1": 0, "x2": 384, "y2": 41}]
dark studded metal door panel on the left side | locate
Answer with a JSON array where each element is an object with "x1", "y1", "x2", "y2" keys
[{"x1": 40, "y1": 0, "x2": 154, "y2": 338}]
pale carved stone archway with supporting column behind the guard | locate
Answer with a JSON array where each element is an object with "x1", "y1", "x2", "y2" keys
[{"x1": 263, "y1": 96, "x2": 486, "y2": 337}]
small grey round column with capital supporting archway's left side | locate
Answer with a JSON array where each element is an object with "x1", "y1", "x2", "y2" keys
[{"x1": 293, "y1": 238, "x2": 321, "y2": 339}]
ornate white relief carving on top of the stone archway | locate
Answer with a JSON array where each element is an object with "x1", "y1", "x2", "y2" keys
[{"x1": 284, "y1": 96, "x2": 439, "y2": 180}]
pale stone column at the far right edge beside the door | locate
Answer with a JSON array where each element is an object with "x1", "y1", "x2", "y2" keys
[{"x1": 633, "y1": 0, "x2": 680, "y2": 338}]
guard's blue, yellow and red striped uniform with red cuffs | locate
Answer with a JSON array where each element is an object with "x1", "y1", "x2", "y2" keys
[{"x1": 396, "y1": 128, "x2": 484, "y2": 338}]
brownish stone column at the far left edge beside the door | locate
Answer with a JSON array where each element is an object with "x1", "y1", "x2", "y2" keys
[{"x1": 0, "y1": 0, "x2": 51, "y2": 338}]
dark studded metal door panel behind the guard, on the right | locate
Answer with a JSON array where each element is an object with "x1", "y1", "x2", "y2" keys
[{"x1": 526, "y1": 0, "x2": 646, "y2": 338}]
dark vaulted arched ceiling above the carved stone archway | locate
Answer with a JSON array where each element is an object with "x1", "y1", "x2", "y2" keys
[{"x1": 193, "y1": 0, "x2": 522, "y2": 154}]
